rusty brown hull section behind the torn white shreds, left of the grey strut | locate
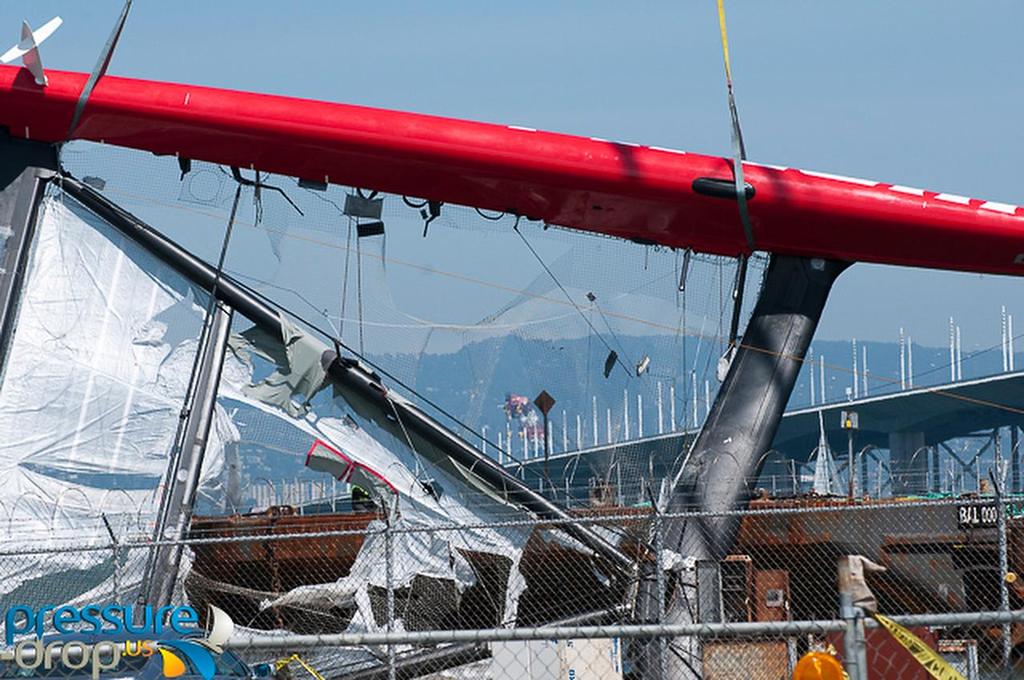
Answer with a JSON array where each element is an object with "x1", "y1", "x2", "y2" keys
[{"x1": 185, "y1": 508, "x2": 644, "y2": 633}]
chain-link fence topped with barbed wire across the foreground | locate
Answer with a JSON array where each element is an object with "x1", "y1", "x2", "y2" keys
[{"x1": 0, "y1": 496, "x2": 1024, "y2": 680}]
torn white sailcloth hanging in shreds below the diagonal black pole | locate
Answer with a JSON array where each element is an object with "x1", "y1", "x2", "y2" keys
[{"x1": 220, "y1": 318, "x2": 529, "y2": 630}]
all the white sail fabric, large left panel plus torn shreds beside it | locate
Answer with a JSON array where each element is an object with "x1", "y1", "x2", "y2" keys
[{"x1": 0, "y1": 194, "x2": 528, "y2": 630}]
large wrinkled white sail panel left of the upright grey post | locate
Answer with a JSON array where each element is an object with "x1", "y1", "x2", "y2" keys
[{"x1": 0, "y1": 195, "x2": 238, "y2": 593}]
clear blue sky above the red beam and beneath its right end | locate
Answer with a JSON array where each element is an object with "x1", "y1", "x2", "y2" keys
[{"x1": 0, "y1": 0, "x2": 1024, "y2": 349}]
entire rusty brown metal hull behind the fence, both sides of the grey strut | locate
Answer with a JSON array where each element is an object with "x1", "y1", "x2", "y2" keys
[{"x1": 185, "y1": 498, "x2": 1024, "y2": 641}]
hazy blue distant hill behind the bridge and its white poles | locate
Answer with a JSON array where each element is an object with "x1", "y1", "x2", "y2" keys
[{"x1": 374, "y1": 335, "x2": 1024, "y2": 443}]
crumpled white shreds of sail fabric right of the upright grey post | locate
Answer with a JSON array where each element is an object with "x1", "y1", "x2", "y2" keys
[{"x1": 219, "y1": 329, "x2": 528, "y2": 631}]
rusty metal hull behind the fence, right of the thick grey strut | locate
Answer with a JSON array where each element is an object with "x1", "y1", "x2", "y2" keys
[{"x1": 737, "y1": 499, "x2": 1019, "y2": 619}]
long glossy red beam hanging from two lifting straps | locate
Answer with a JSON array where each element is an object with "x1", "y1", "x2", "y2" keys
[{"x1": 0, "y1": 67, "x2": 1024, "y2": 275}]
